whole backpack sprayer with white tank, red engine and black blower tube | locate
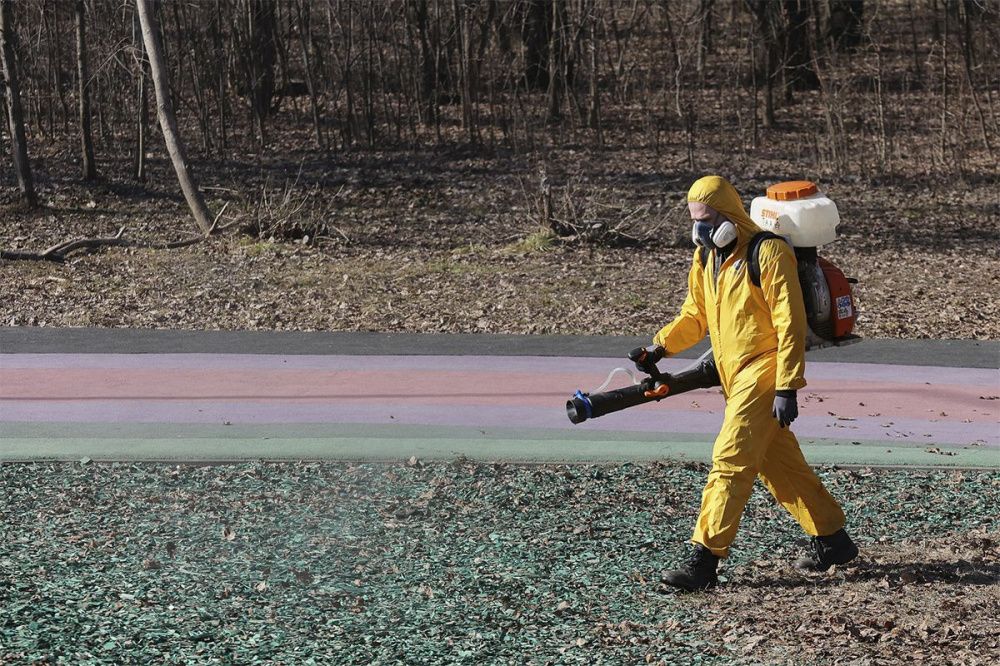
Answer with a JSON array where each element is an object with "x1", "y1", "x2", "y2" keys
[{"x1": 566, "y1": 180, "x2": 861, "y2": 423}]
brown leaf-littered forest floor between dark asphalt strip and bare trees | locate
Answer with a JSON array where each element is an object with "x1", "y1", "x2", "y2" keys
[{"x1": 0, "y1": 141, "x2": 1000, "y2": 339}]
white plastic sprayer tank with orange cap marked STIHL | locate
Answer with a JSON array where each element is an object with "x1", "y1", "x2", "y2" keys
[{"x1": 750, "y1": 180, "x2": 840, "y2": 247}]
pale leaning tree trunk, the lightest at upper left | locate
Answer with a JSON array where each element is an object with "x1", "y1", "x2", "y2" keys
[{"x1": 136, "y1": 0, "x2": 212, "y2": 233}]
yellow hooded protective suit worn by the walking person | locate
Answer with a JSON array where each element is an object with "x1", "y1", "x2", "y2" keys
[{"x1": 654, "y1": 176, "x2": 844, "y2": 557}]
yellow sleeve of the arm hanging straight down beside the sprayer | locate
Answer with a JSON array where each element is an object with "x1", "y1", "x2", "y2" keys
[{"x1": 759, "y1": 240, "x2": 808, "y2": 391}]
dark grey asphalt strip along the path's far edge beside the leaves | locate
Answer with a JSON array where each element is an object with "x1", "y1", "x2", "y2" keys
[{"x1": 0, "y1": 327, "x2": 1000, "y2": 368}]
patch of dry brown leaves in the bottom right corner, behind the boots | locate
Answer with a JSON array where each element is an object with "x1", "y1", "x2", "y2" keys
[{"x1": 698, "y1": 532, "x2": 1000, "y2": 664}]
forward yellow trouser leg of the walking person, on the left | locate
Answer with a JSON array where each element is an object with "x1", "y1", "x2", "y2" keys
[{"x1": 691, "y1": 368, "x2": 780, "y2": 557}]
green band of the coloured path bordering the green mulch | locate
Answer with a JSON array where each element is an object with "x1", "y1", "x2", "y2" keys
[{"x1": 0, "y1": 423, "x2": 1000, "y2": 468}]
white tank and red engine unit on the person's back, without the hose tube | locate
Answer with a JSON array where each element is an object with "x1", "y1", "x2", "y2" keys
[{"x1": 750, "y1": 180, "x2": 860, "y2": 349}]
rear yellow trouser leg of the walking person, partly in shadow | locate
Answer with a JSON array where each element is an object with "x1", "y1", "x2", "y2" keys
[{"x1": 760, "y1": 428, "x2": 844, "y2": 536}]
